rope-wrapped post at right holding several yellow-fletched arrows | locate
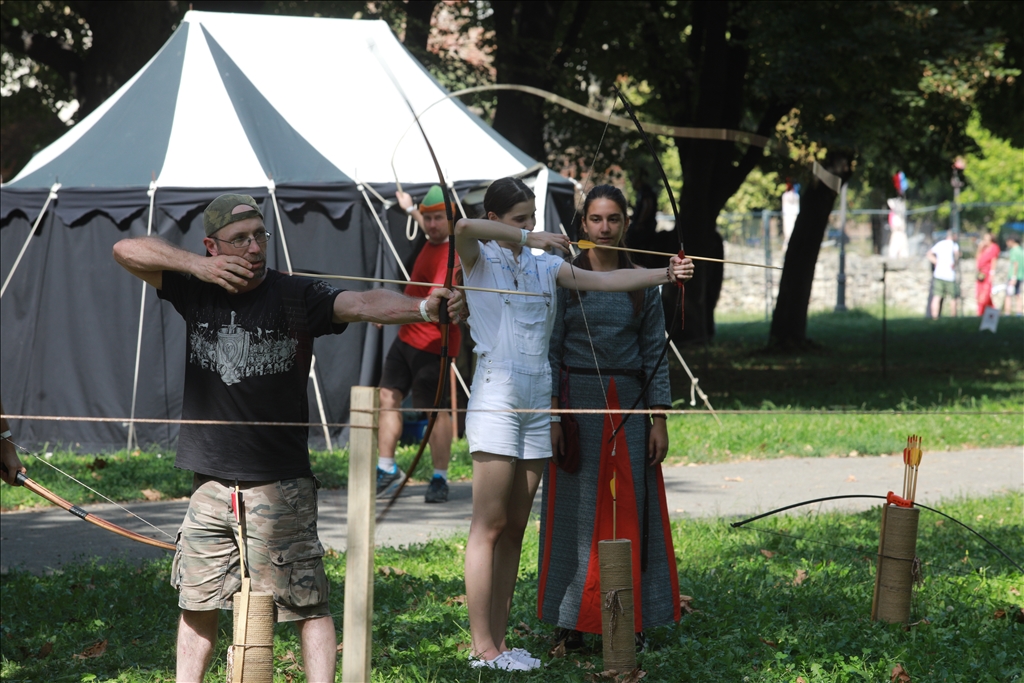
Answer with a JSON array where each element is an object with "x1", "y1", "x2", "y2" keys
[{"x1": 871, "y1": 503, "x2": 921, "y2": 624}]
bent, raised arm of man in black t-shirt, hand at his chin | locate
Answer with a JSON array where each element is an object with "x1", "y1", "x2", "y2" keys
[{"x1": 114, "y1": 237, "x2": 253, "y2": 294}]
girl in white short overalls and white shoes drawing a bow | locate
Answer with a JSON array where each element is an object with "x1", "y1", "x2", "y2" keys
[{"x1": 456, "y1": 178, "x2": 693, "y2": 671}]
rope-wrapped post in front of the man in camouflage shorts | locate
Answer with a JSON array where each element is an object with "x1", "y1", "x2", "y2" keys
[{"x1": 227, "y1": 593, "x2": 274, "y2": 683}]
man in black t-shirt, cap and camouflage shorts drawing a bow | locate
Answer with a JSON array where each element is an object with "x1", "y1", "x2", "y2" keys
[{"x1": 114, "y1": 195, "x2": 466, "y2": 681}]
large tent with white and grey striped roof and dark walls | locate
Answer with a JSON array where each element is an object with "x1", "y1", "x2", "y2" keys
[{"x1": 0, "y1": 11, "x2": 572, "y2": 449}]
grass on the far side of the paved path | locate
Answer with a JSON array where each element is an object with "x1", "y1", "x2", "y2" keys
[{"x1": 0, "y1": 310, "x2": 1024, "y2": 509}]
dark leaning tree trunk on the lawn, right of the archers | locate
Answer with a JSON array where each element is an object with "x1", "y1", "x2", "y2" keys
[{"x1": 768, "y1": 156, "x2": 850, "y2": 350}]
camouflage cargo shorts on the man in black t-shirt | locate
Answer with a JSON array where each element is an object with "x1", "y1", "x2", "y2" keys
[{"x1": 171, "y1": 474, "x2": 330, "y2": 622}]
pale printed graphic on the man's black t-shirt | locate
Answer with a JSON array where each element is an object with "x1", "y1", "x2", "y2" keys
[{"x1": 188, "y1": 311, "x2": 299, "y2": 385}]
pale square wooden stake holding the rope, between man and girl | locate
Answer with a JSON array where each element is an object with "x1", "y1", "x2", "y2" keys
[{"x1": 341, "y1": 387, "x2": 380, "y2": 683}]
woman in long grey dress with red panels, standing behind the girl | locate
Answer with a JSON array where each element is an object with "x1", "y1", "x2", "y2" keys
[{"x1": 538, "y1": 185, "x2": 680, "y2": 649}]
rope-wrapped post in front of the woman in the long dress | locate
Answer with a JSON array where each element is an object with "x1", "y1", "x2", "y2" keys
[{"x1": 597, "y1": 539, "x2": 637, "y2": 674}]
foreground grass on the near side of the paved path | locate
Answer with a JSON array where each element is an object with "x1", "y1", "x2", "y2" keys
[{"x1": 0, "y1": 495, "x2": 1024, "y2": 683}]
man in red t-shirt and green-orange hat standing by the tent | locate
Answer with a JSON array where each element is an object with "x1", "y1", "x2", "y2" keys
[{"x1": 377, "y1": 185, "x2": 460, "y2": 503}]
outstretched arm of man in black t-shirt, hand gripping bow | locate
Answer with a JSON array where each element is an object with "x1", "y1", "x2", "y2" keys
[{"x1": 334, "y1": 288, "x2": 467, "y2": 325}]
